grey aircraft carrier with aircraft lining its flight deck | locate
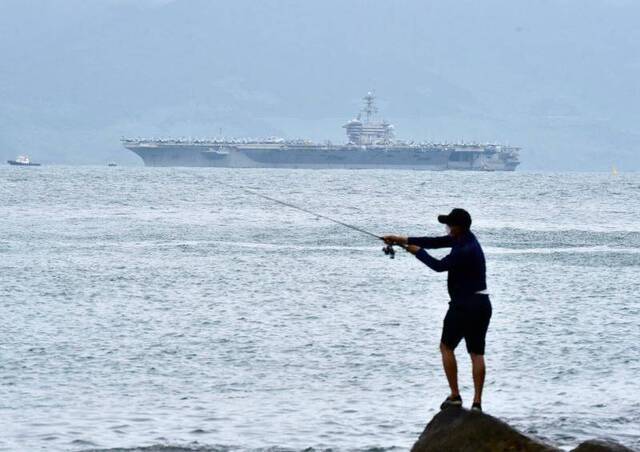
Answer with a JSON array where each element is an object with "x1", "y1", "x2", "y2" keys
[{"x1": 122, "y1": 93, "x2": 520, "y2": 171}]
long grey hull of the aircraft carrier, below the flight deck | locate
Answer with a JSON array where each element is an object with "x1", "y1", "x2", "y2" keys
[{"x1": 125, "y1": 144, "x2": 517, "y2": 171}]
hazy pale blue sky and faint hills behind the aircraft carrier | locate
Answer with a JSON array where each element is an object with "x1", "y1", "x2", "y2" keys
[{"x1": 0, "y1": 0, "x2": 640, "y2": 170}]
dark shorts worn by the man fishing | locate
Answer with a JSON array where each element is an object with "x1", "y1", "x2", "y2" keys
[{"x1": 441, "y1": 295, "x2": 491, "y2": 355}]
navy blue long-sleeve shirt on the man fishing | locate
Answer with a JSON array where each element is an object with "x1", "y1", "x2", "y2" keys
[{"x1": 407, "y1": 232, "x2": 487, "y2": 301}]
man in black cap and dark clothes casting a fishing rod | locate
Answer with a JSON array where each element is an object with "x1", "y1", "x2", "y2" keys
[{"x1": 383, "y1": 209, "x2": 491, "y2": 411}]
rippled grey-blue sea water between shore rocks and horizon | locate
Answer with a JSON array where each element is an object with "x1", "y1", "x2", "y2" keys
[{"x1": 0, "y1": 167, "x2": 640, "y2": 451}]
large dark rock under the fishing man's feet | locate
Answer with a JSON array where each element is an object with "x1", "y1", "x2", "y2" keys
[{"x1": 411, "y1": 408, "x2": 559, "y2": 452}]
